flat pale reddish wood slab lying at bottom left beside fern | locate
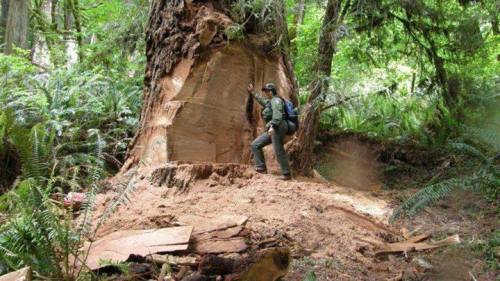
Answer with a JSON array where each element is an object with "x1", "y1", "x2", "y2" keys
[{"x1": 86, "y1": 226, "x2": 193, "y2": 270}]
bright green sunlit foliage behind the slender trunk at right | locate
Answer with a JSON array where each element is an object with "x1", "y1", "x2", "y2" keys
[{"x1": 288, "y1": 0, "x2": 500, "y2": 145}]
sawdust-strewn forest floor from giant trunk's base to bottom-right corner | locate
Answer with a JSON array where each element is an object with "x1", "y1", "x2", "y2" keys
[{"x1": 92, "y1": 137, "x2": 499, "y2": 280}]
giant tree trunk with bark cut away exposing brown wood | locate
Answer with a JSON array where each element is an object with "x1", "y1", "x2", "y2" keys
[{"x1": 123, "y1": 0, "x2": 296, "y2": 171}]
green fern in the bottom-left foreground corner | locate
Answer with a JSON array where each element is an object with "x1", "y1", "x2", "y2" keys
[{"x1": 0, "y1": 125, "x2": 101, "y2": 280}]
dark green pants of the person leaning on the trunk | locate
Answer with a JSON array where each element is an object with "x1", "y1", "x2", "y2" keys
[{"x1": 251, "y1": 121, "x2": 290, "y2": 175}]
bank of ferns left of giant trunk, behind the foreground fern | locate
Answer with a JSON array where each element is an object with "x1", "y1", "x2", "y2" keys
[{"x1": 0, "y1": 53, "x2": 141, "y2": 191}]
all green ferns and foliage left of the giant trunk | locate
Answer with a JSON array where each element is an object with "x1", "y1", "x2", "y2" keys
[{"x1": 0, "y1": 0, "x2": 149, "y2": 280}]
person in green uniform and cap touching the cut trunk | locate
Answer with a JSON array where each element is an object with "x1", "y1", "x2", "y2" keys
[{"x1": 247, "y1": 83, "x2": 291, "y2": 180}]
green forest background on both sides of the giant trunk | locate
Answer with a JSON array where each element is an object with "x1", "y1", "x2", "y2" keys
[{"x1": 0, "y1": 0, "x2": 500, "y2": 276}]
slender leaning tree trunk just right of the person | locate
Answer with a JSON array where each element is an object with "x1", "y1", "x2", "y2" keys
[{"x1": 289, "y1": 0, "x2": 340, "y2": 175}]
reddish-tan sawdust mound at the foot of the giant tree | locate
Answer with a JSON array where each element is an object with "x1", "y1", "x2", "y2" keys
[{"x1": 96, "y1": 164, "x2": 402, "y2": 280}]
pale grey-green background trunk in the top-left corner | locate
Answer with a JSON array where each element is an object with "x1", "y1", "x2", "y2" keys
[{"x1": 5, "y1": 0, "x2": 31, "y2": 54}]
